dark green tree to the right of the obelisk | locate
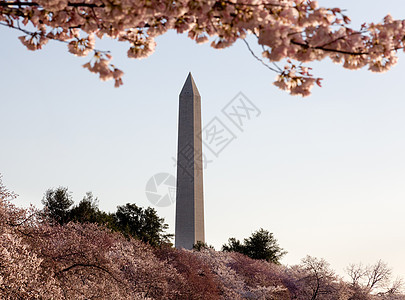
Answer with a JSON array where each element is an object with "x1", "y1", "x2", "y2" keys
[{"x1": 222, "y1": 228, "x2": 287, "y2": 264}]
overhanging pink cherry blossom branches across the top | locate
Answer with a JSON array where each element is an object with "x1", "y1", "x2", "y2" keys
[{"x1": 0, "y1": 0, "x2": 405, "y2": 96}]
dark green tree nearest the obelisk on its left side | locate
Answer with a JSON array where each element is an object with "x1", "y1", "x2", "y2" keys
[{"x1": 114, "y1": 203, "x2": 173, "y2": 246}]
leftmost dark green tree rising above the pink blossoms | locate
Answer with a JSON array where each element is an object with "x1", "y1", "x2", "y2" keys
[{"x1": 42, "y1": 186, "x2": 73, "y2": 225}]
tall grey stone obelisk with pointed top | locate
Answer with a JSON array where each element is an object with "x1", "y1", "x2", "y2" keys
[{"x1": 175, "y1": 73, "x2": 205, "y2": 249}]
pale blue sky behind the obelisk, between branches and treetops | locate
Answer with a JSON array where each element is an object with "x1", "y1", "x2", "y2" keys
[{"x1": 0, "y1": 0, "x2": 405, "y2": 277}]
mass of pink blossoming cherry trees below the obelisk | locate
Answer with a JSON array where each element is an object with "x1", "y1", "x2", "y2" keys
[{"x1": 0, "y1": 176, "x2": 405, "y2": 300}]
